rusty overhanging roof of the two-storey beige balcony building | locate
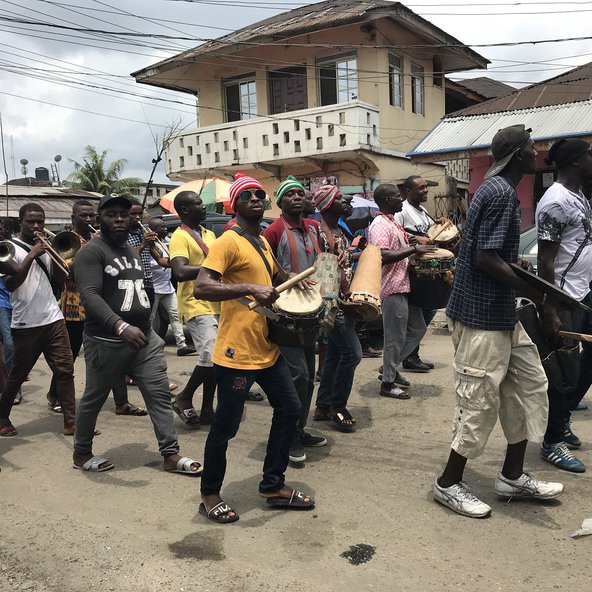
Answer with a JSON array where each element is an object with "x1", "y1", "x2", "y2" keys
[{"x1": 131, "y1": 0, "x2": 489, "y2": 81}]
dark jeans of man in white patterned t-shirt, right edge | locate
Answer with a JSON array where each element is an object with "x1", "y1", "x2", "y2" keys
[{"x1": 545, "y1": 292, "x2": 592, "y2": 444}]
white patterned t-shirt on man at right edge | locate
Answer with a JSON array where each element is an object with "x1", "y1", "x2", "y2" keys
[{"x1": 536, "y1": 183, "x2": 592, "y2": 300}]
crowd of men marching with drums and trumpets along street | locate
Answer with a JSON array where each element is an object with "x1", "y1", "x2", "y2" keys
[{"x1": 0, "y1": 125, "x2": 592, "y2": 524}]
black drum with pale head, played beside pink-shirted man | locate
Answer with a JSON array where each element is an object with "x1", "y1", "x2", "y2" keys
[{"x1": 409, "y1": 249, "x2": 454, "y2": 310}]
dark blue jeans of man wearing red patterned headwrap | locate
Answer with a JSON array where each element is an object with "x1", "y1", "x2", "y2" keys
[{"x1": 316, "y1": 315, "x2": 362, "y2": 409}]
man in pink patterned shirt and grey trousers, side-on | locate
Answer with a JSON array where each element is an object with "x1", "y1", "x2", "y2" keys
[{"x1": 368, "y1": 184, "x2": 436, "y2": 399}]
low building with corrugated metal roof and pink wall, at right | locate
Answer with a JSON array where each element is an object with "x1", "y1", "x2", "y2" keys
[{"x1": 409, "y1": 62, "x2": 592, "y2": 228}]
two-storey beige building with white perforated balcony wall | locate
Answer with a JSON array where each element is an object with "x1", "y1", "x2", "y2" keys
[{"x1": 132, "y1": 0, "x2": 488, "y2": 214}]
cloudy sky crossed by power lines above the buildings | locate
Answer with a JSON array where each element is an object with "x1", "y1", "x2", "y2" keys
[{"x1": 0, "y1": 0, "x2": 592, "y2": 182}]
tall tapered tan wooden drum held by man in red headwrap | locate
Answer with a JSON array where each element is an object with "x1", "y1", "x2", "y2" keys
[{"x1": 340, "y1": 245, "x2": 382, "y2": 321}]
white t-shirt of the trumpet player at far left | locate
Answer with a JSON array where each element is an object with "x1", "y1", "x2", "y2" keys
[{"x1": 10, "y1": 242, "x2": 64, "y2": 329}]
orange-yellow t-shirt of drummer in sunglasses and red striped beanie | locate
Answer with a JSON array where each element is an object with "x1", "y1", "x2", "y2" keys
[{"x1": 203, "y1": 230, "x2": 280, "y2": 370}]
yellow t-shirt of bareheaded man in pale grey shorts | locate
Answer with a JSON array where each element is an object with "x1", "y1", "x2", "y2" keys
[{"x1": 169, "y1": 227, "x2": 220, "y2": 322}]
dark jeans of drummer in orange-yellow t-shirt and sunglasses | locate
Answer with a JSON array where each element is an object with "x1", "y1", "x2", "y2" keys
[{"x1": 201, "y1": 356, "x2": 301, "y2": 495}]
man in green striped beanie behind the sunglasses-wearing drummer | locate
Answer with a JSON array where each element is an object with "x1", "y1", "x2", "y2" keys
[{"x1": 263, "y1": 175, "x2": 327, "y2": 463}]
